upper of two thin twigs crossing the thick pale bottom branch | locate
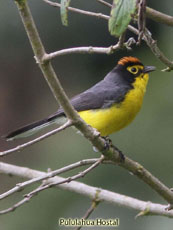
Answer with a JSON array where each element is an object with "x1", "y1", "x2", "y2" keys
[{"x1": 0, "y1": 159, "x2": 99, "y2": 200}]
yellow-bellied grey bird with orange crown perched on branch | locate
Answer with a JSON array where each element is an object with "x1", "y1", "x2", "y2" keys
[{"x1": 6, "y1": 57, "x2": 155, "y2": 140}]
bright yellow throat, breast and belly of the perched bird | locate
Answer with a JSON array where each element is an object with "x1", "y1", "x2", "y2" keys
[{"x1": 79, "y1": 74, "x2": 148, "y2": 136}]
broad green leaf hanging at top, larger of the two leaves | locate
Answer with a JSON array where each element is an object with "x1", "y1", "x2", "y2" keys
[{"x1": 109, "y1": 0, "x2": 136, "y2": 37}]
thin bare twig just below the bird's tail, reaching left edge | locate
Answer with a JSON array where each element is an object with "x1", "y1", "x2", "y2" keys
[{"x1": 0, "y1": 120, "x2": 73, "y2": 157}]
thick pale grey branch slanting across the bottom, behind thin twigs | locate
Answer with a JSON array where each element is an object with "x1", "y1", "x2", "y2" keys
[{"x1": 0, "y1": 162, "x2": 173, "y2": 218}]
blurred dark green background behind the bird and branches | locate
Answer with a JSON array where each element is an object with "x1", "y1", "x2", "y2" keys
[{"x1": 0, "y1": 0, "x2": 173, "y2": 230}]
